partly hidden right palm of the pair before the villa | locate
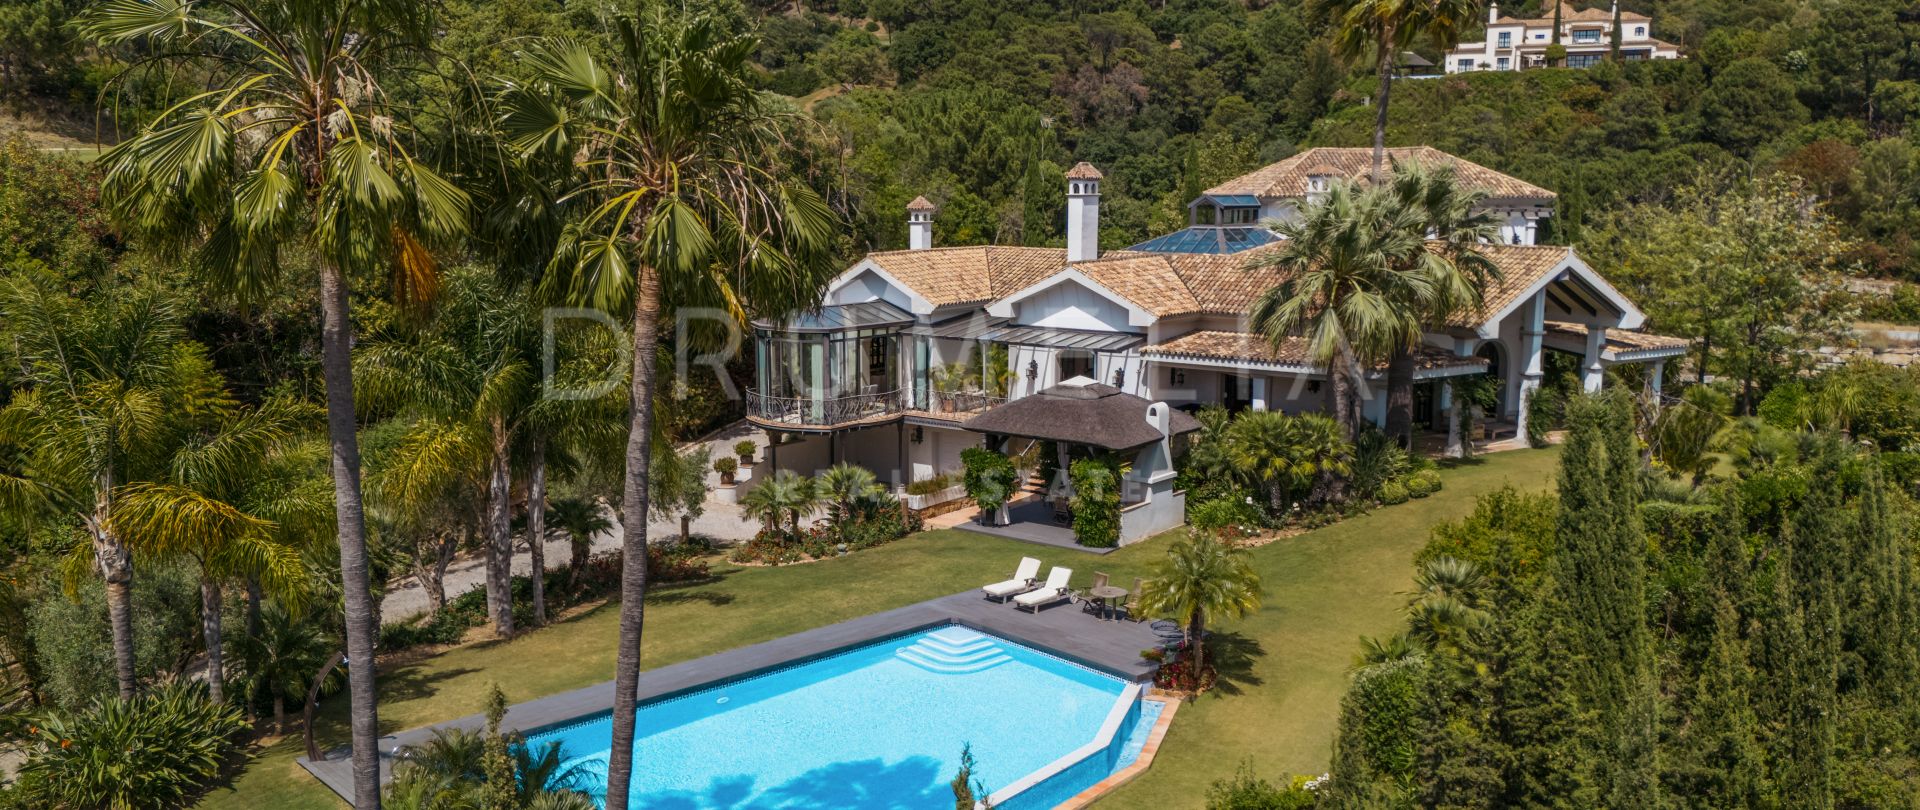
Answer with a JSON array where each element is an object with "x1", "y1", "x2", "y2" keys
[{"x1": 1386, "y1": 163, "x2": 1500, "y2": 447}]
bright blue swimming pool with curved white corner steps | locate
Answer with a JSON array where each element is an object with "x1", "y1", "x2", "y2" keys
[{"x1": 528, "y1": 626, "x2": 1158, "y2": 810}]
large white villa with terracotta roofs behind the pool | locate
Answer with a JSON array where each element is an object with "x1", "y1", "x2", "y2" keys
[{"x1": 747, "y1": 148, "x2": 1686, "y2": 543}]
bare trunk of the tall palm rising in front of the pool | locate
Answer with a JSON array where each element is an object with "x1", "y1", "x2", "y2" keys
[{"x1": 607, "y1": 264, "x2": 660, "y2": 810}]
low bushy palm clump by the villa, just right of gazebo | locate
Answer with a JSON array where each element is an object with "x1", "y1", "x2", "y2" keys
[{"x1": 1225, "y1": 411, "x2": 1354, "y2": 511}]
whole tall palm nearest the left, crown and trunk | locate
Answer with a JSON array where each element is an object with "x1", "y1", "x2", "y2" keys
[{"x1": 77, "y1": 0, "x2": 467, "y2": 810}]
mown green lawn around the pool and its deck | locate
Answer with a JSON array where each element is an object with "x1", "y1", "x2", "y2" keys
[{"x1": 200, "y1": 451, "x2": 1555, "y2": 810}]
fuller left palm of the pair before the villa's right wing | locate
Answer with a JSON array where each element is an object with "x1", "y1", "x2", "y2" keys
[{"x1": 1246, "y1": 182, "x2": 1432, "y2": 438}]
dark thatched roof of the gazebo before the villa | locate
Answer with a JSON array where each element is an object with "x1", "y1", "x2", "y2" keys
[{"x1": 966, "y1": 376, "x2": 1200, "y2": 451}]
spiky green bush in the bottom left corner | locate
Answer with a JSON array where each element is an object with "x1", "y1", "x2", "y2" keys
[{"x1": 17, "y1": 681, "x2": 248, "y2": 810}]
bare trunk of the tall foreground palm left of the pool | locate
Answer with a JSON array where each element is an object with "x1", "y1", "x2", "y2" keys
[{"x1": 321, "y1": 261, "x2": 380, "y2": 810}]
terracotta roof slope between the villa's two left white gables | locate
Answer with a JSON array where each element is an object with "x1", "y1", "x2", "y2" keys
[{"x1": 866, "y1": 246, "x2": 1068, "y2": 307}]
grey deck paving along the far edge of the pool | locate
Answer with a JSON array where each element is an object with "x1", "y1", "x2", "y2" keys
[{"x1": 300, "y1": 583, "x2": 1160, "y2": 802}]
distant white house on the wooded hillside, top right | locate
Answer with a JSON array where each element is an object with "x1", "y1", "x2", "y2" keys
[{"x1": 1446, "y1": 0, "x2": 1680, "y2": 73}]
